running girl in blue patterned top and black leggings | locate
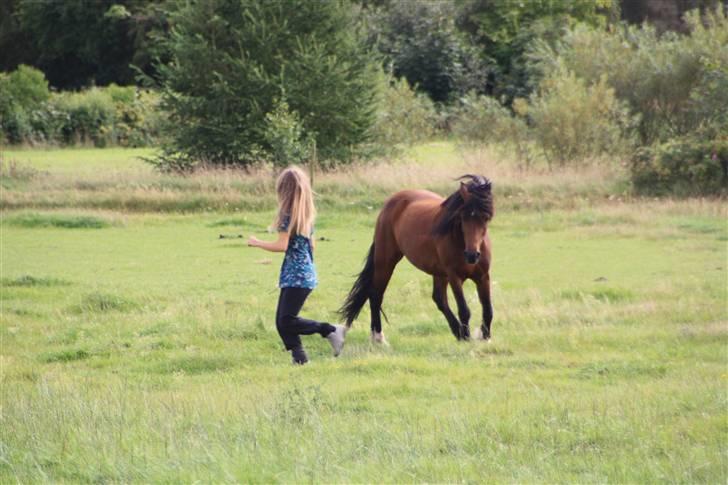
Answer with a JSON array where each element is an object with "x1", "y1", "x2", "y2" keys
[{"x1": 248, "y1": 167, "x2": 346, "y2": 364}]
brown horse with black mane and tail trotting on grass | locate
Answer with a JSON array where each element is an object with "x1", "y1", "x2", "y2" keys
[{"x1": 339, "y1": 175, "x2": 493, "y2": 342}]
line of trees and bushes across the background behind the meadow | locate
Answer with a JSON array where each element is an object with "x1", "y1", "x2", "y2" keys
[{"x1": 0, "y1": 0, "x2": 728, "y2": 195}]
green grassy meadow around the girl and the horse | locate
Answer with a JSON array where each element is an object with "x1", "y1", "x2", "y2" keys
[{"x1": 0, "y1": 143, "x2": 728, "y2": 483}]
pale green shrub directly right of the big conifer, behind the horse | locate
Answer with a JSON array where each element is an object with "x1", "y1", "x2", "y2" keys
[{"x1": 372, "y1": 76, "x2": 438, "y2": 151}]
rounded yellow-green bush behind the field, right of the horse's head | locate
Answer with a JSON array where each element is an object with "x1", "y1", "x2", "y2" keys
[{"x1": 528, "y1": 69, "x2": 634, "y2": 165}]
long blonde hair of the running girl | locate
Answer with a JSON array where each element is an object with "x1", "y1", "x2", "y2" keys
[{"x1": 275, "y1": 165, "x2": 316, "y2": 237}]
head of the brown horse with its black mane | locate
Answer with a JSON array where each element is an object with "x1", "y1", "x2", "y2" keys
[{"x1": 435, "y1": 175, "x2": 494, "y2": 264}]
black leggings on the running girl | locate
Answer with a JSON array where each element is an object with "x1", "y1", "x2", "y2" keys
[{"x1": 276, "y1": 288, "x2": 336, "y2": 350}]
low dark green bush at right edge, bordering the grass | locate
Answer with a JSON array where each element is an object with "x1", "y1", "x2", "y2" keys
[{"x1": 631, "y1": 133, "x2": 728, "y2": 196}]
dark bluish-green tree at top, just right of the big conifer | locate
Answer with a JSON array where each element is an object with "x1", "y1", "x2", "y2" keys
[{"x1": 365, "y1": 2, "x2": 487, "y2": 102}]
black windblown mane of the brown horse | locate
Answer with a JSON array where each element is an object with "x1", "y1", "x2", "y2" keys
[{"x1": 432, "y1": 174, "x2": 494, "y2": 236}]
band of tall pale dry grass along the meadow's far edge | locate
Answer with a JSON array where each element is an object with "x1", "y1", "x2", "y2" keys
[{"x1": 0, "y1": 143, "x2": 624, "y2": 212}]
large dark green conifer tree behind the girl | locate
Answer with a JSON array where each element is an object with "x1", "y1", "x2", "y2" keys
[{"x1": 159, "y1": 0, "x2": 378, "y2": 167}]
